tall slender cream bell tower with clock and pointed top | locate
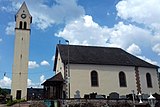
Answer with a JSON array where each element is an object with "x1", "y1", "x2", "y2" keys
[{"x1": 11, "y1": 2, "x2": 32, "y2": 99}]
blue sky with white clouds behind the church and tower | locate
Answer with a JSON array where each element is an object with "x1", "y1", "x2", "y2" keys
[{"x1": 0, "y1": 0, "x2": 160, "y2": 88}]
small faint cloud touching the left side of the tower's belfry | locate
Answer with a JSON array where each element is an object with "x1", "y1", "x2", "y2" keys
[{"x1": 5, "y1": 22, "x2": 15, "y2": 35}]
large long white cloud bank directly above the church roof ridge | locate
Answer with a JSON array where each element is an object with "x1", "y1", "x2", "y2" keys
[{"x1": 55, "y1": 15, "x2": 152, "y2": 49}]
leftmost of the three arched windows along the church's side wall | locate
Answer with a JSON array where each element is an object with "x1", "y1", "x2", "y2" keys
[{"x1": 91, "y1": 71, "x2": 98, "y2": 87}]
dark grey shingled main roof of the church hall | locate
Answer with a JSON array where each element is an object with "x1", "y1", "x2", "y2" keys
[{"x1": 54, "y1": 44, "x2": 159, "y2": 70}]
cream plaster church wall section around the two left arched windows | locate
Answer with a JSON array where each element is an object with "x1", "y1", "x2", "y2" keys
[{"x1": 70, "y1": 64, "x2": 136, "y2": 98}]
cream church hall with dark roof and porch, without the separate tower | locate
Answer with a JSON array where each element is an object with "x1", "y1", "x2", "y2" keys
[{"x1": 42, "y1": 44, "x2": 159, "y2": 99}]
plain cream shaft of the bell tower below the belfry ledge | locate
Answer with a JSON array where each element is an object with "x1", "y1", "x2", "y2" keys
[{"x1": 11, "y1": 30, "x2": 30, "y2": 99}]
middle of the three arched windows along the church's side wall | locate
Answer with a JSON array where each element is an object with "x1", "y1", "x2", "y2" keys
[{"x1": 119, "y1": 71, "x2": 127, "y2": 87}]
